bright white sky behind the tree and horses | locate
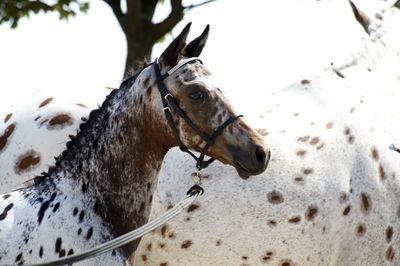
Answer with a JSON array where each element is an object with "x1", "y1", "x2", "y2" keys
[{"x1": 0, "y1": 0, "x2": 394, "y2": 109}]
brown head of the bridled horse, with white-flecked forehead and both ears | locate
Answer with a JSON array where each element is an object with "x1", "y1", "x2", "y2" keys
[{"x1": 155, "y1": 23, "x2": 270, "y2": 178}]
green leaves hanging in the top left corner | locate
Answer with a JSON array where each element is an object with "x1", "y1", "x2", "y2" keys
[{"x1": 0, "y1": 0, "x2": 89, "y2": 28}]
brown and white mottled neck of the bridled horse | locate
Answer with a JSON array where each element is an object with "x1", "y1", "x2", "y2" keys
[{"x1": 47, "y1": 68, "x2": 174, "y2": 254}]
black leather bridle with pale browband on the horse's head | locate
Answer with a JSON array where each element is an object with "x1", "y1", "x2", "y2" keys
[{"x1": 153, "y1": 58, "x2": 243, "y2": 170}]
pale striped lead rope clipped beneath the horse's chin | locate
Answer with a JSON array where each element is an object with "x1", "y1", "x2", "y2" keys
[{"x1": 28, "y1": 181, "x2": 204, "y2": 266}]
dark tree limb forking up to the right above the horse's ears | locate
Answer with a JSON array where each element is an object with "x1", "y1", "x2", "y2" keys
[{"x1": 154, "y1": 0, "x2": 185, "y2": 42}]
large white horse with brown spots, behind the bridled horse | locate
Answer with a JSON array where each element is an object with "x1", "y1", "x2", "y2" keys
[{"x1": 0, "y1": 2, "x2": 400, "y2": 266}]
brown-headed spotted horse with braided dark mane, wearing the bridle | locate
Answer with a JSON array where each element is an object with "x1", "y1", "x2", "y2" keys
[{"x1": 0, "y1": 24, "x2": 269, "y2": 265}]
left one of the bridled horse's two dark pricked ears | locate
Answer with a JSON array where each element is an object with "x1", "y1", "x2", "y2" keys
[{"x1": 159, "y1": 23, "x2": 192, "y2": 71}]
